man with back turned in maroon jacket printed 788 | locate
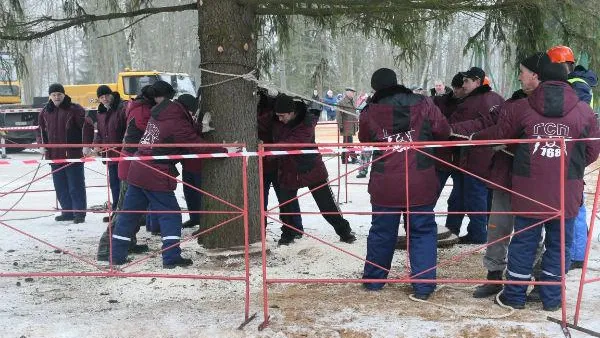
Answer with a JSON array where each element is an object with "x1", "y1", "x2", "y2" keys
[{"x1": 473, "y1": 63, "x2": 600, "y2": 311}]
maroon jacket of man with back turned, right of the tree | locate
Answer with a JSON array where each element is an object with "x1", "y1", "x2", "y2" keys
[{"x1": 358, "y1": 86, "x2": 450, "y2": 208}]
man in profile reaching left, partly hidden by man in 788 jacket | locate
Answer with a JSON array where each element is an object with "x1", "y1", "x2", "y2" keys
[{"x1": 452, "y1": 52, "x2": 550, "y2": 298}]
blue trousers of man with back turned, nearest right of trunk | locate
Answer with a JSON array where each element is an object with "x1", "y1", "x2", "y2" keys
[{"x1": 363, "y1": 205, "x2": 437, "y2": 295}]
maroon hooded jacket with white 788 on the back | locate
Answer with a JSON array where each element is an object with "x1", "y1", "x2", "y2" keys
[{"x1": 495, "y1": 81, "x2": 600, "y2": 219}]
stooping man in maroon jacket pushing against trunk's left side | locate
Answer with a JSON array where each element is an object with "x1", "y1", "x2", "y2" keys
[{"x1": 112, "y1": 81, "x2": 229, "y2": 269}]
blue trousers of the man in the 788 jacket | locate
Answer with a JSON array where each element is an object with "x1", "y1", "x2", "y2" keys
[{"x1": 502, "y1": 216, "x2": 574, "y2": 307}]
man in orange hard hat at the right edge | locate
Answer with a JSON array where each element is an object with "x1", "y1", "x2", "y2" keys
[{"x1": 547, "y1": 45, "x2": 598, "y2": 269}]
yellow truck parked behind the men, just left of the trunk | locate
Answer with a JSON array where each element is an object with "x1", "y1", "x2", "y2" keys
[{"x1": 64, "y1": 69, "x2": 196, "y2": 111}]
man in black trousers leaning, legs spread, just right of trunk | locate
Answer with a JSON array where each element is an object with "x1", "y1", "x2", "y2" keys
[{"x1": 273, "y1": 94, "x2": 356, "y2": 245}]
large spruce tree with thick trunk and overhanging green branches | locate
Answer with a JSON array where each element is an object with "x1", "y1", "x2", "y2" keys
[{"x1": 0, "y1": 0, "x2": 600, "y2": 247}]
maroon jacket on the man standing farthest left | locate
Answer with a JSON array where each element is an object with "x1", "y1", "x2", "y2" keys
[{"x1": 37, "y1": 95, "x2": 94, "y2": 160}]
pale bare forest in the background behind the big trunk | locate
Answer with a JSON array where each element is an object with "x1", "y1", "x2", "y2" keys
[{"x1": 16, "y1": 0, "x2": 518, "y2": 103}]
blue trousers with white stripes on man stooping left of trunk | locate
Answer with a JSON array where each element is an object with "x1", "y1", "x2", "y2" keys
[{"x1": 112, "y1": 184, "x2": 181, "y2": 264}]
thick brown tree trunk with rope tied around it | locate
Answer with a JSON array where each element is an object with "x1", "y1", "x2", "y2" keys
[{"x1": 198, "y1": 0, "x2": 260, "y2": 248}]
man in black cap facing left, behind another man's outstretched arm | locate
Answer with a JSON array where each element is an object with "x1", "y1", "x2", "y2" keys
[{"x1": 446, "y1": 67, "x2": 504, "y2": 244}]
